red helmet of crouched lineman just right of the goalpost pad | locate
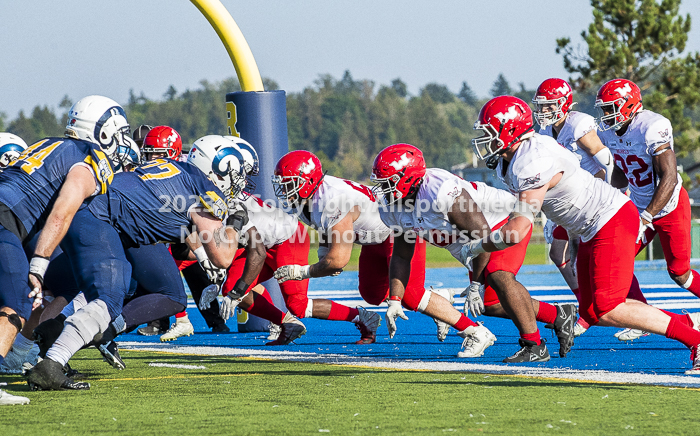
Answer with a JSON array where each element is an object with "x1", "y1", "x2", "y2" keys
[{"x1": 272, "y1": 150, "x2": 323, "y2": 207}]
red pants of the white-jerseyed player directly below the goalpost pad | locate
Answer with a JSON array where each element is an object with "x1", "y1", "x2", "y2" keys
[{"x1": 222, "y1": 223, "x2": 309, "y2": 318}]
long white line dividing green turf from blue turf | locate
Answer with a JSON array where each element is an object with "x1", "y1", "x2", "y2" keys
[{"x1": 119, "y1": 342, "x2": 700, "y2": 387}]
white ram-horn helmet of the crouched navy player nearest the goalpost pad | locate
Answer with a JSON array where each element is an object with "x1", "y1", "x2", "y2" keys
[{"x1": 187, "y1": 135, "x2": 246, "y2": 204}]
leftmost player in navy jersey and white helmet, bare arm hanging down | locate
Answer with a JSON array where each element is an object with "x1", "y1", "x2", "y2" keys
[{"x1": 0, "y1": 96, "x2": 132, "y2": 390}]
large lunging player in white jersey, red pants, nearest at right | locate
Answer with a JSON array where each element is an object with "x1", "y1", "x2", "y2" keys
[{"x1": 461, "y1": 96, "x2": 700, "y2": 374}]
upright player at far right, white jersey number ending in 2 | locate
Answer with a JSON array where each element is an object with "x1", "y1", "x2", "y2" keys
[{"x1": 595, "y1": 79, "x2": 700, "y2": 340}]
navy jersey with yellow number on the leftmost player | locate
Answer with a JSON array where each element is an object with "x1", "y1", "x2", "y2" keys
[{"x1": 0, "y1": 138, "x2": 114, "y2": 235}]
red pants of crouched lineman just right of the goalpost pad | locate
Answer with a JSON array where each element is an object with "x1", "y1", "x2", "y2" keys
[{"x1": 359, "y1": 237, "x2": 426, "y2": 310}]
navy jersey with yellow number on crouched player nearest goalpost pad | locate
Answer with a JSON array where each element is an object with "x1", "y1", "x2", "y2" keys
[{"x1": 88, "y1": 159, "x2": 228, "y2": 245}]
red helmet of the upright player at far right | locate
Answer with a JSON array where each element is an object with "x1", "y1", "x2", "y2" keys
[{"x1": 595, "y1": 79, "x2": 642, "y2": 130}]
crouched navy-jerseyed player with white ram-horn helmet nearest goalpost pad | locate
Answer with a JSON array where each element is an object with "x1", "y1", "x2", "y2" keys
[{"x1": 28, "y1": 135, "x2": 247, "y2": 389}]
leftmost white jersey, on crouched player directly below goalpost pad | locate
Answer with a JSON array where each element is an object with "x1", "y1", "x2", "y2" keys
[{"x1": 240, "y1": 194, "x2": 299, "y2": 249}]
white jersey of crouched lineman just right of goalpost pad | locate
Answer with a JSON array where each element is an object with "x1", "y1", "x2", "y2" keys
[{"x1": 299, "y1": 176, "x2": 391, "y2": 245}]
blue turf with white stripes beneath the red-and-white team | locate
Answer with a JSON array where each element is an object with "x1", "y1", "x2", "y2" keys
[{"x1": 121, "y1": 261, "x2": 700, "y2": 375}]
